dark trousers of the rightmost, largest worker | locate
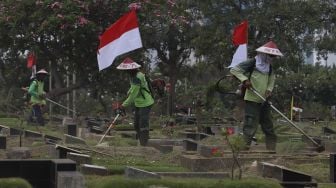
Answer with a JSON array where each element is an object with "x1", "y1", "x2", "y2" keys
[{"x1": 243, "y1": 101, "x2": 277, "y2": 150}]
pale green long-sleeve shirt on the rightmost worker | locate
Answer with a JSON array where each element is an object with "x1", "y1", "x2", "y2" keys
[{"x1": 230, "y1": 58, "x2": 275, "y2": 103}]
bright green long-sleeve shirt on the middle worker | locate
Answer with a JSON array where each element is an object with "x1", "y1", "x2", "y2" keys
[{"x1": 122, "y1": 72, "x2": 154, "y2": 107}]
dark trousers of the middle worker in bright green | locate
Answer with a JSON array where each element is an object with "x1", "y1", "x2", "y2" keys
[{"x1": 134, "y1": 106, "x2": 152, "y2": 146}]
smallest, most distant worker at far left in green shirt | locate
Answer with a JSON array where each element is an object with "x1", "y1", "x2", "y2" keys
[{"x1": 28, "y1": 69, "x2": 48, "y2": 126}]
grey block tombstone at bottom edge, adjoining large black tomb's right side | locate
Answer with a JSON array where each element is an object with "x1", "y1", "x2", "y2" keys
[{"x1": 57, "y1": 171, "x2": 85, "y2": 188}]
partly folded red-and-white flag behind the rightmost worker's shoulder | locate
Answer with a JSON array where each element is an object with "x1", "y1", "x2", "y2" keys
[{"x1": 229, "y1": 20, "x2": 248, "y2": 68}]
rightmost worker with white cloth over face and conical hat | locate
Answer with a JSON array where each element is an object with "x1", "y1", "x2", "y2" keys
[{"x1": 230, "y1": 41, "x2": 283, "y2": 150}]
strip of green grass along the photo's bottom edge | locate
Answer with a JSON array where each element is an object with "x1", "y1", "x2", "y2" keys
[{"x1": 87, "y1": 176, "x2": 281, "y2": 188}]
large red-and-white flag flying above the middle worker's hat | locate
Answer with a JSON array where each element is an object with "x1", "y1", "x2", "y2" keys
[{"x1": 97, "y1": 10, "x2": 142, "y2": 71}]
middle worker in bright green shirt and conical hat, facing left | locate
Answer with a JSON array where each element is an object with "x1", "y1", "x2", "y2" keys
[{"x1": 117, "y1": 58, "x2": 154, "y2": 146}]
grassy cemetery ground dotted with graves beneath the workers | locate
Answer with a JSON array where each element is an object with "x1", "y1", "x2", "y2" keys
[{"x1": 0, "y1": 113, "x2": 336, "y2": 188}]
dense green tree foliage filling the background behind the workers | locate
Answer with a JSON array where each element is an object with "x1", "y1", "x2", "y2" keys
[{"x1": 0, "y1": 0, "x2": 336, "y2": 116}]
